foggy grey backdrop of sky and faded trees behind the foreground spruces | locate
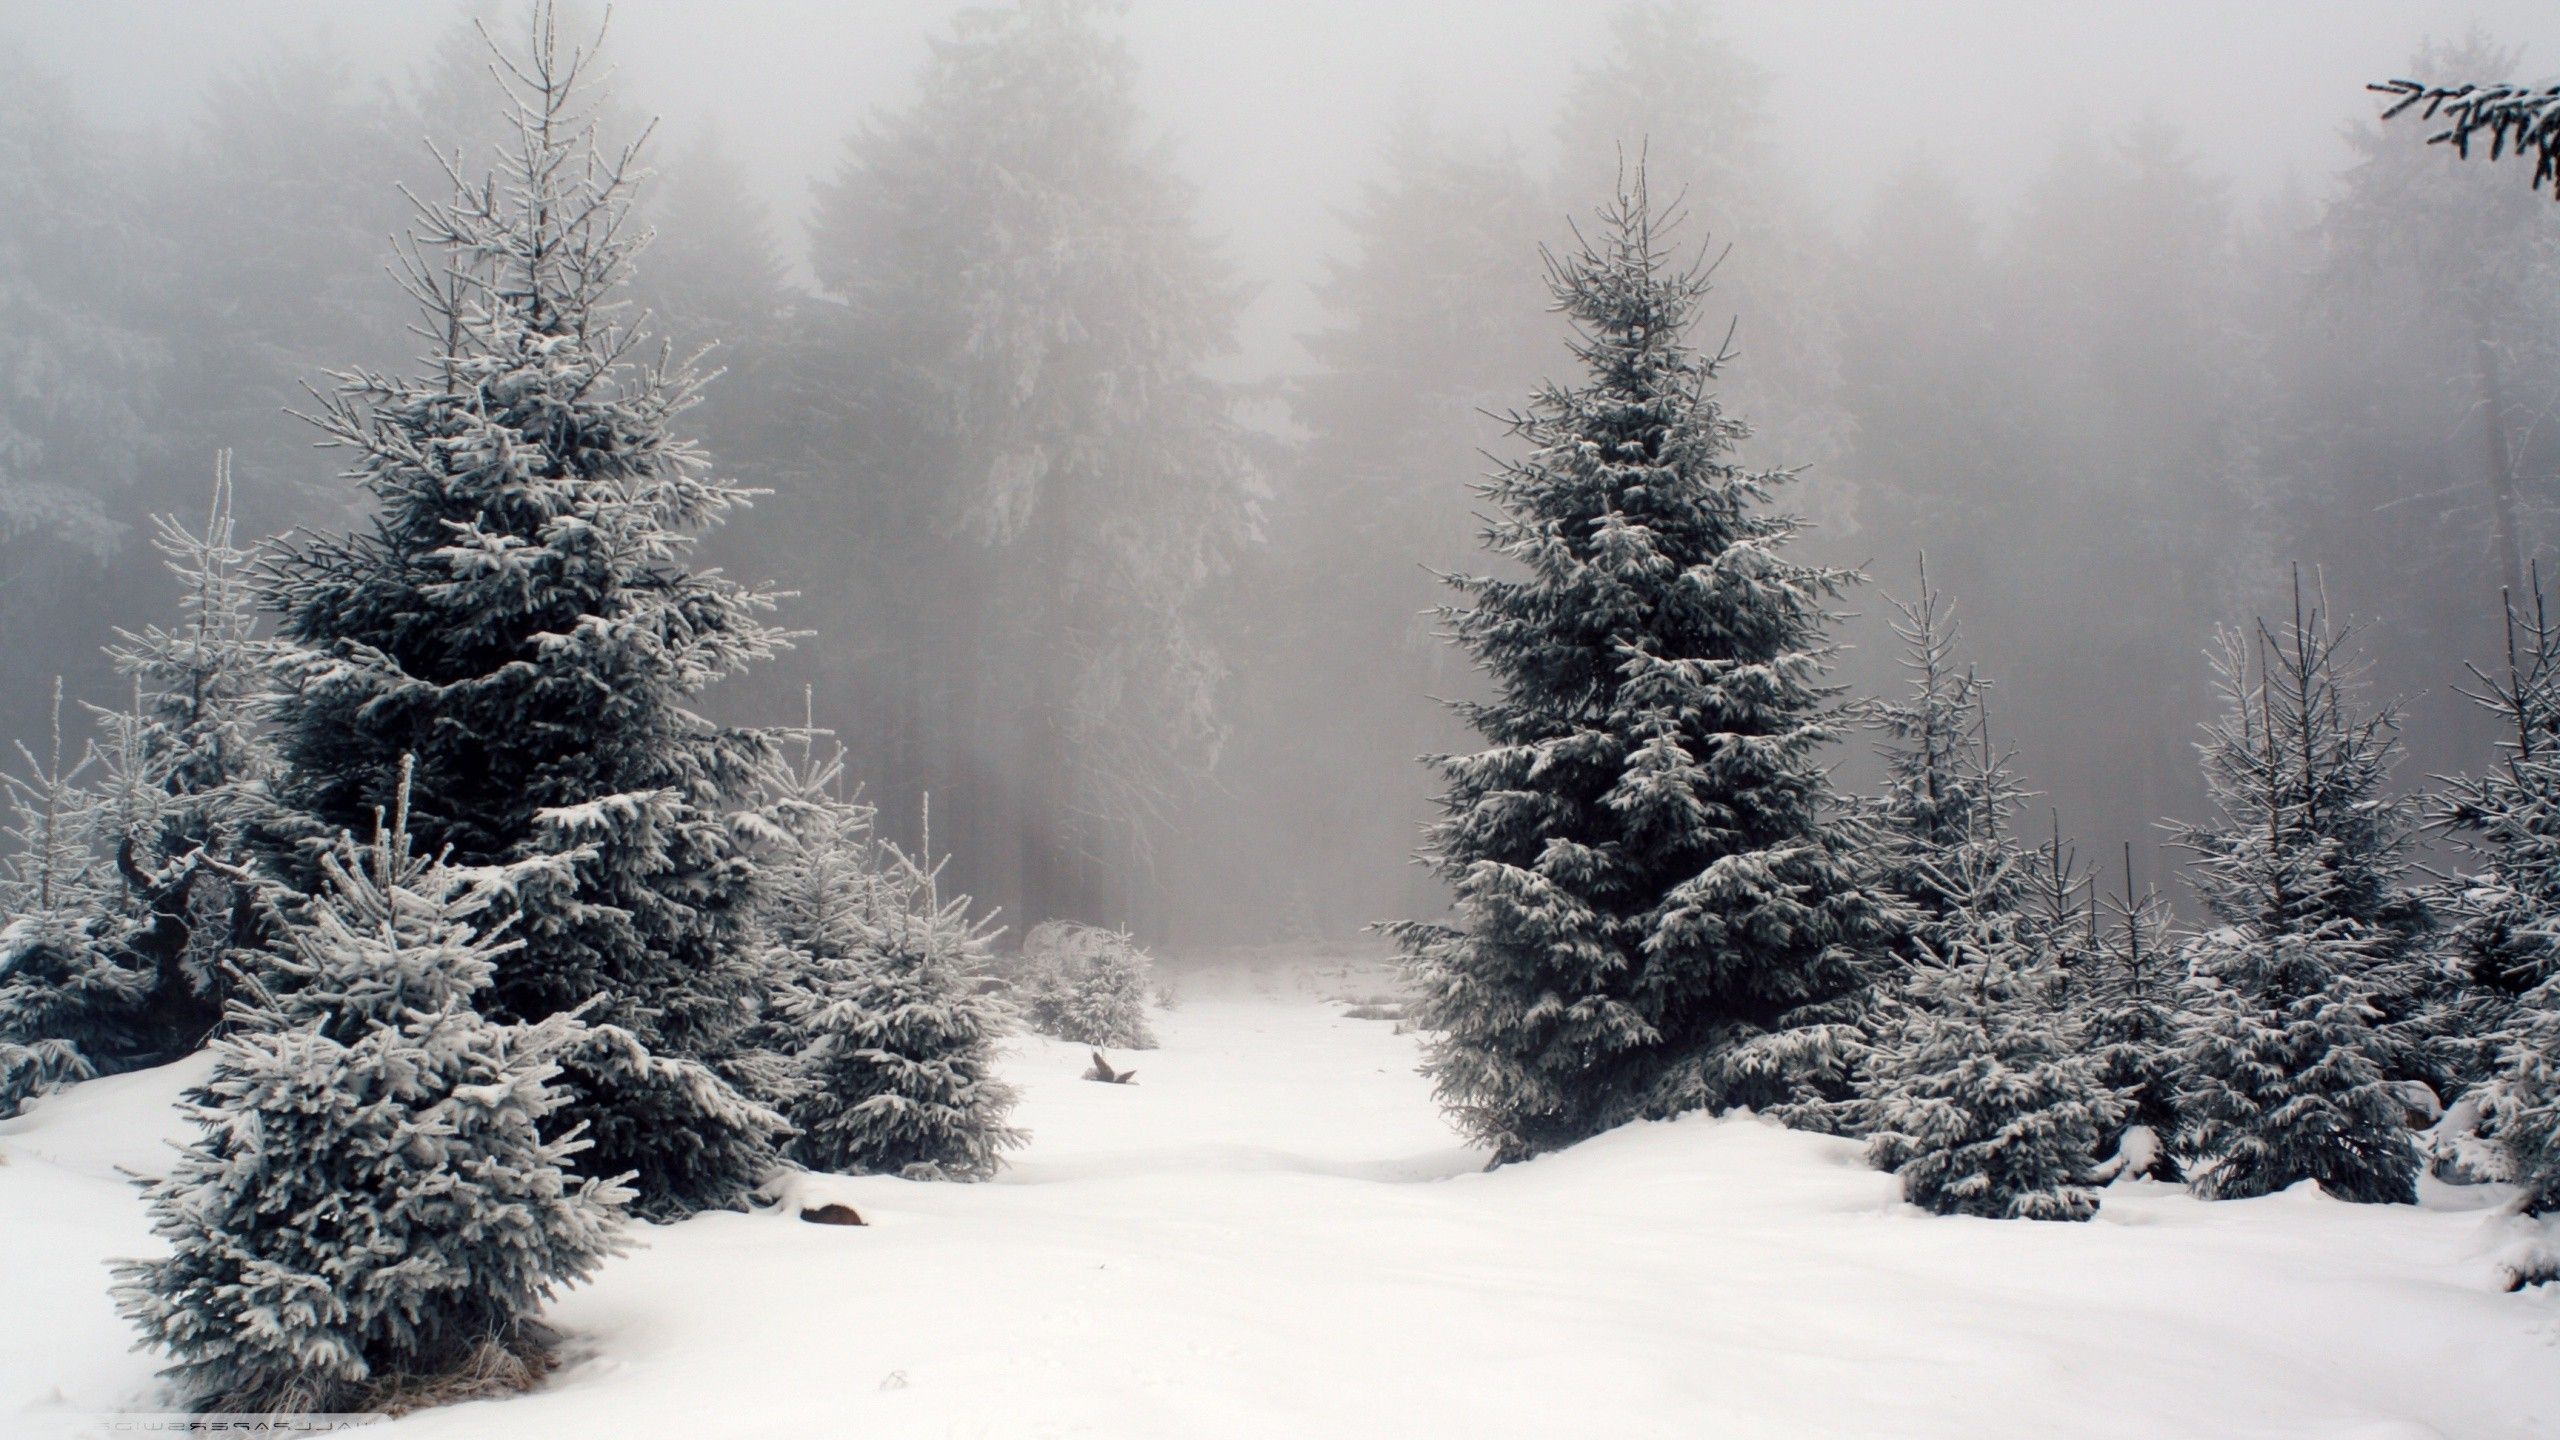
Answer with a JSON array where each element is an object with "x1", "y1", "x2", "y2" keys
[{"x1": 0, "y1": 0, "x2": 2560, "y2": 945}]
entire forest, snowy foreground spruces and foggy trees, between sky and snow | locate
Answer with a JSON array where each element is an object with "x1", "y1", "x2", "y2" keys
[{"x1": 0, "y1": 0, "x2": 2560, "y2": 1409}]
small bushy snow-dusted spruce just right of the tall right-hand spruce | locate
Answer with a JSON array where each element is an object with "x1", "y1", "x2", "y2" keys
[{"x1": 1864, "y1": 846, "x2": 2122, "y2": 1220}]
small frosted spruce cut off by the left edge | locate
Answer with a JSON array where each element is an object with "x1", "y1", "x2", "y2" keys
[{"x1": 0, "y1": 679, "x2": 151, "y2": 1117}]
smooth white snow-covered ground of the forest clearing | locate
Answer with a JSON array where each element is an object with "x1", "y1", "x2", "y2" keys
[{"x1": 0, "y1": 969, "x2": 2560, "y2": 1440}]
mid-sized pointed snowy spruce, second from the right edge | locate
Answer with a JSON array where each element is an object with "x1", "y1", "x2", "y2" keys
[{"x1": 2179, "y1": 599, "x2": 2419, "y2": 1202}]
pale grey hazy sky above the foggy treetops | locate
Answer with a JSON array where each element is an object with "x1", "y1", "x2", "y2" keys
[{"x1": 0, "y1": 0, "x2": 2560, "y2": 369}]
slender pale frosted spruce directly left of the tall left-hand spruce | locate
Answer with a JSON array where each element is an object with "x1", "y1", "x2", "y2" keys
[{"x1": 90, "y1": 451, "x2": 276, "y2": 1058}]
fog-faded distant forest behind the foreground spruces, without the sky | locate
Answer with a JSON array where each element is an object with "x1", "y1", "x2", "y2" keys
[{"x1": 0, "y1": 5, "x2": 2560, "y2": 943}]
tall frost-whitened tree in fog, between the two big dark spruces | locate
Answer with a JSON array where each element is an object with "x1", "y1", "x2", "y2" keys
[{"x1": 812, "y1": 0, "x2": 1262, "y2": 917}]
